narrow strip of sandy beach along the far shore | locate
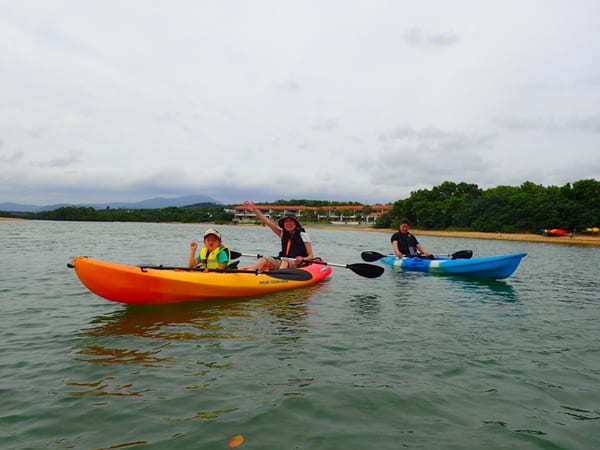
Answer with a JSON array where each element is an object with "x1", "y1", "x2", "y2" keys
[{"x1": 0, "y1": 217, "x2": 600, "y2": 247}]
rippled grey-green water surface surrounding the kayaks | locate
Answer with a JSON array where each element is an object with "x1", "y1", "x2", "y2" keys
[{"x1": 0, "y1": 221, "x2": 600, "y2": 449}]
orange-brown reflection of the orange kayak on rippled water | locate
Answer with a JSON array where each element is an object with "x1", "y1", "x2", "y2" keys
[{"x1": 68, "y1": 285, "x2": 322, "y2": 410}]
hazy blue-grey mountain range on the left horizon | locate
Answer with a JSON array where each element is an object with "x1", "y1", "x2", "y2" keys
[{"x1": 0, "y1": 195, "x2": 220, "y2": 212}]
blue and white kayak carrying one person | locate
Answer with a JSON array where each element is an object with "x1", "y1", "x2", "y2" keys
[{"x1": 380, "y1": 253, "x2": 527, "y2": 279}]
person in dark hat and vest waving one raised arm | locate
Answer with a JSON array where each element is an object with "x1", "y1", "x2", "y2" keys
[{"x1": 244, "y1": 201, "x2": 314, "y2": 271}]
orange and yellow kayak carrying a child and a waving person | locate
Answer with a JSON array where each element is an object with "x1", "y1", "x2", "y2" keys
[{"x1": 69, "y1": 256, "x2": 331, "y2": 305}]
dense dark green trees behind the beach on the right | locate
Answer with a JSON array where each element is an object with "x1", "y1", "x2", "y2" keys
[{"x1": 376, "y1": 179, "x2": 600, "y2": 233}]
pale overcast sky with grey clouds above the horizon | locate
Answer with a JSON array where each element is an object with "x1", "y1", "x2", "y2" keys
[{"x1": 0, "y1": 0, "x2": 600, "y2": 205}]
